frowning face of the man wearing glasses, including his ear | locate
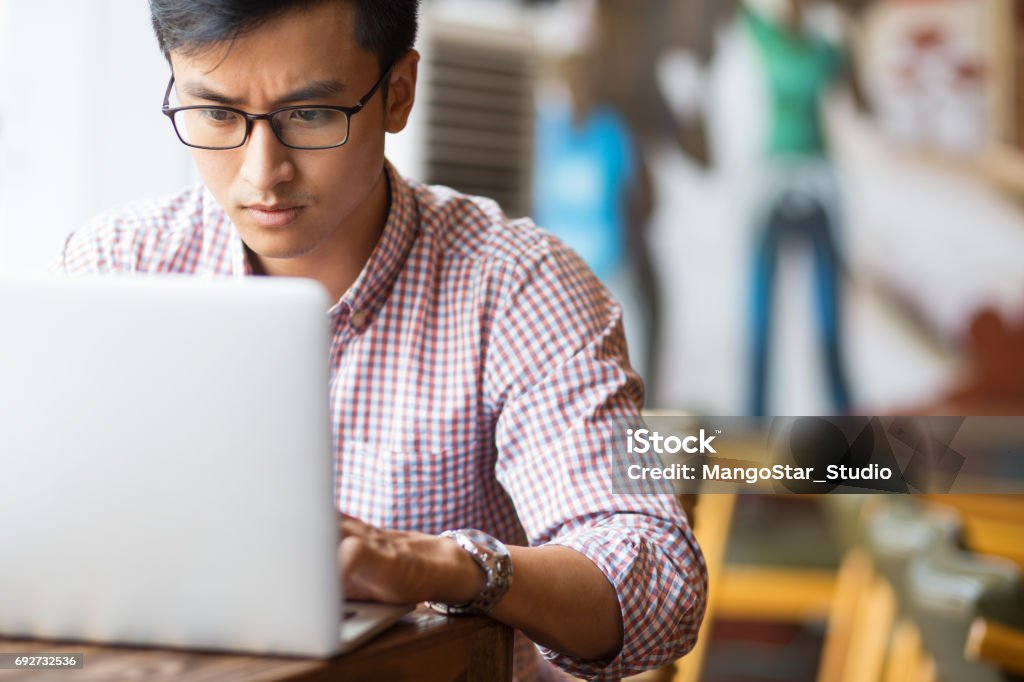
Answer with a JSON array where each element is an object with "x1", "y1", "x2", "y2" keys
[{"x1": 171, "y1": 2, "x2": 416, "y2": 258}]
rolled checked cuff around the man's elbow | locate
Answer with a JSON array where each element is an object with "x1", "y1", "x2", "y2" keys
[{"x1": 538, "y1": 526, "x2": 705, "y2": 681}]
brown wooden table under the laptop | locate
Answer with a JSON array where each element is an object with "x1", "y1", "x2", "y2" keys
[{"x1": 0, "y1": 607, "x2": 512, "y2": 682}]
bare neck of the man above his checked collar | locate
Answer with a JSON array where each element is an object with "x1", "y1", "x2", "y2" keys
[{"x1": 246, "y1": 164, "x2": 391, "y2": 301}]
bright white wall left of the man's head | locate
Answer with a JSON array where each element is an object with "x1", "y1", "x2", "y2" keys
[{"x1": 0, "y1": 0, "x2": 195, "y2": 272}]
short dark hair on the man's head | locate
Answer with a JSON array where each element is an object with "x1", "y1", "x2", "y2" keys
[{"x1": 150, "y1": 0, "x2": 420, "y2": 69}]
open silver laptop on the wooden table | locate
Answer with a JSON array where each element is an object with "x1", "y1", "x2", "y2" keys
[{"x1": 0, "y1": 278, "x2": 410, "y2": 656}]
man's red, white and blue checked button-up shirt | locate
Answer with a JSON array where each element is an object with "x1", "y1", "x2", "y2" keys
[{"x1": 60, "y1": 164, "x2": 706, "y2": 680}]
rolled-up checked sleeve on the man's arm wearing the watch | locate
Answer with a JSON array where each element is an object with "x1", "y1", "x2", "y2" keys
[{"x1": 487, "y1": 232, "x2": 707, "y2": 680}]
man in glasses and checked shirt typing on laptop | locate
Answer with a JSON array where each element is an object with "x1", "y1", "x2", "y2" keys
[{"x1": 62, "y1": 0, "x2": 706, "y2": 679}]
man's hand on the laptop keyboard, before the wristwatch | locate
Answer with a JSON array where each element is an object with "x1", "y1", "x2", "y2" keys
[{"x1": 338, "y1": 514, "x2": 484, "y2": 604}]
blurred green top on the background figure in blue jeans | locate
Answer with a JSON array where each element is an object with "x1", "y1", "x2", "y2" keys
[{"x1": 740, "y1": 3, "x2": 843, "y2": 157}]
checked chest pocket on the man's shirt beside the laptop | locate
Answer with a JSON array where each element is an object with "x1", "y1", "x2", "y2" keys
[{"x1": 335, "y1": 440, "x2": 479, "y2": 532}]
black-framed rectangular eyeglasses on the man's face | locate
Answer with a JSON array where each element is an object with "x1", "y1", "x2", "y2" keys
[{"x1": 161, "y1": 63, "x2": 394, "y2": 150}]
